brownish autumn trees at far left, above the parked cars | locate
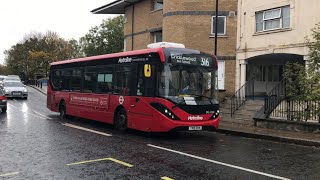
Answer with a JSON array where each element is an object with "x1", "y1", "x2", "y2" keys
[{"x1": 5, "y1": 31, "x2": 82, "y2": 80}]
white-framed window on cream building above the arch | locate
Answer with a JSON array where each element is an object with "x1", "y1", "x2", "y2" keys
[{"x1": 256, "y1": 6, "x2": 290, "y2": 32}]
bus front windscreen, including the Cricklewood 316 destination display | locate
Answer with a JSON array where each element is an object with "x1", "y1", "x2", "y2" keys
[{"x1": 158, "y1": 51, "x2": 218, "y2": 105}]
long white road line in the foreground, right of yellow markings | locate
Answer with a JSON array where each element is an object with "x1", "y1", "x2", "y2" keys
[{"x1": 147, "y1": 144, "x2": 290, "y2": 180}]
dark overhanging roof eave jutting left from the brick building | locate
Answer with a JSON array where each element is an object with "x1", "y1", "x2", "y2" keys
[{"x1": 91, "y1": 0, "x2": 142, "y2": 14}]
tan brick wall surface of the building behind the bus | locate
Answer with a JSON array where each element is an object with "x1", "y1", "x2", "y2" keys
[{"x1": 125, "y1": 0, "x2": 237, "y2": 96}]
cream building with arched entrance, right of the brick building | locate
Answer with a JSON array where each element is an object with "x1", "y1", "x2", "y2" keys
[{"x1": 236, "y1": 0, "x2": 320, "y2": 95}]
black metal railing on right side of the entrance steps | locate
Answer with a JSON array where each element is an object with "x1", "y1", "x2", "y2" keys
[{"x1": 264, "y1": 79, "x2": 286, "y2": 117}]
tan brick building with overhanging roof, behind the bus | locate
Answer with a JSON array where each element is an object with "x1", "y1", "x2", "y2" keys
[{"x1": 92, "y1": 0, "x2": 237, "y2": 97}]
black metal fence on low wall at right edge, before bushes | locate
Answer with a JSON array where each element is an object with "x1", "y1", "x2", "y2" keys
[{"x1": 269, "y1": 97, "x2": 320, "y2": 123}]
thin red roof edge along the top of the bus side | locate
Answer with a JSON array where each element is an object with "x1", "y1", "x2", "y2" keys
[{"x1": 51, "y1": 48, "x2": 164, "y2": 66}]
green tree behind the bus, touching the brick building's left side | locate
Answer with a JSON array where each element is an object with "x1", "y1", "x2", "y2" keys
[{"x1": 80, "y1": 16, "x2": 124, "y2": 56}]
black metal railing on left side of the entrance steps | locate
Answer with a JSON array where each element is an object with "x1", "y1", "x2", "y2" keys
[{"x1": 230, "y1": 77, "x2": 254, "y2": 117}]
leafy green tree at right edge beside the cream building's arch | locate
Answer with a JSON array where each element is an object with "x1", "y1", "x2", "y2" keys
[{"x1": 284, "y1": 23, "x2": 320, "y2": 122}]
